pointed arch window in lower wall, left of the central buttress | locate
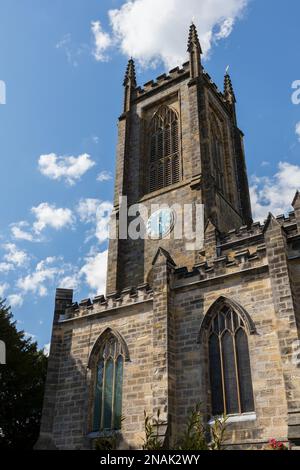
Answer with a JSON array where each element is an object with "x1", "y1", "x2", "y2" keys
[{"x1": 93, "y1": 331, "x2": 127, "y2": 432}]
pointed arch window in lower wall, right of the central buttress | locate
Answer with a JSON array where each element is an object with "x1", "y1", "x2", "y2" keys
[{"x1": 209, "y1": 307, "x2": 254, "y2": 416}]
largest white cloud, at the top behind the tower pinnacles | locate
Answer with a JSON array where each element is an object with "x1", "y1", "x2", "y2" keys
[{"x1": 105, "y1": 0, "x2": 249, "y2": 68}]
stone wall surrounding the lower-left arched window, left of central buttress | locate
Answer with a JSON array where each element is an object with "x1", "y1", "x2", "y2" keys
[{"x1": 41, "y1": 292, "x2": 153, "y2": 449}]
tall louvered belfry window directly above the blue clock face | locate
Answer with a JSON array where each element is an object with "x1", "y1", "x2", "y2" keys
[{"x1": 148, "y1": 106, "x2": 181, "y2": 192}]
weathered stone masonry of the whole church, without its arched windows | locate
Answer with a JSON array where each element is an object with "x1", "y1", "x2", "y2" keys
[{"x1": 37, "y1": 24, "x2": 300, "y2": 449}]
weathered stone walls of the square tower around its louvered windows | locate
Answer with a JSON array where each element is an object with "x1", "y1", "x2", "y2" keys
[{"x1": 107, "y1": 59, "x2": 249, "y2": 293}]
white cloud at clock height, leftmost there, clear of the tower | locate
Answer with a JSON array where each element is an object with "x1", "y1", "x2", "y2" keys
[{"x1": 31, "y1": 202, "x2": 74, "y2": 234}]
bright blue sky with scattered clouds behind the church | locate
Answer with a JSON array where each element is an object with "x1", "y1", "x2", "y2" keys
[{"x1": 0, "y1": 0, "x2": 300, "y2": 347}]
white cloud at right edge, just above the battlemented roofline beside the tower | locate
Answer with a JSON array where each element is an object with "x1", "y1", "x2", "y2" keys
[{"x1": 250, "y1": 162, "x2": 300, "y2": 221}]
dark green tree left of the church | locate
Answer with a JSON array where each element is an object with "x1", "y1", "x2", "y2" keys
[{"x1": 0, "y1": 300, "x2": 47, "y2": 450}]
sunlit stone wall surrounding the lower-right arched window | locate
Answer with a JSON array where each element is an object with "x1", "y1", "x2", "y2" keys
[{"x1": 175, "y1": 271, "x2": 287, "y2": 447}]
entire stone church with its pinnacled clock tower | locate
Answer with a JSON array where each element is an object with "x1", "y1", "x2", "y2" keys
[{"x1": 37, "y1": 25, "x2": 300, "y2": 449}]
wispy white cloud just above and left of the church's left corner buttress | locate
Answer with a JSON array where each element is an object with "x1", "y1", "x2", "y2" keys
[{"x1": 17, "y1": 257, "x2": 64, "y2": 297}]
